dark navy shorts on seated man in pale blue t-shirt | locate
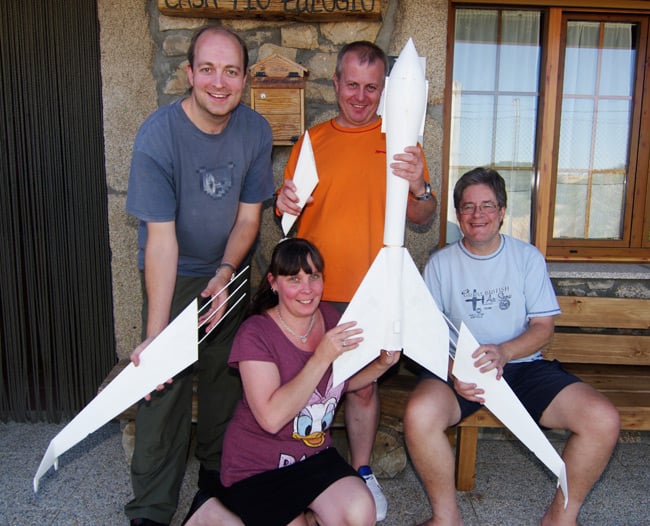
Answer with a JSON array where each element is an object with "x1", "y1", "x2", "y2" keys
[{"x1": 420, "y1": 360, "x2": 582, "y2": 425}]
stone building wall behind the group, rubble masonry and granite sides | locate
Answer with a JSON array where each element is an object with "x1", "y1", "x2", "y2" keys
[{"x1": 98, "y1": 0, "x2": 447, "y2": 357}]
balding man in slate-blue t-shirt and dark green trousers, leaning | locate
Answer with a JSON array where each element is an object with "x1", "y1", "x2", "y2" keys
[{"x1": 125, "y1": 26, "x2": 273, "y2": 526}]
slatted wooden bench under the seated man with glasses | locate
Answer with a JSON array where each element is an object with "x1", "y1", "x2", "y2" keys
[{"x1": 380, "y1": 296, "x2": 650, "y2": 491}]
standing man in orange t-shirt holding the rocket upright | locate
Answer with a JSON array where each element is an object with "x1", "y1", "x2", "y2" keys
[{"x1": 276, "y1": 42, "x2": 436, "y2": 521}]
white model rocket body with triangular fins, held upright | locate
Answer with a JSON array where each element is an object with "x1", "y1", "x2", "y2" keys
[{"x1": 333, "y1": 39, "x2": 449, "y2": 385}]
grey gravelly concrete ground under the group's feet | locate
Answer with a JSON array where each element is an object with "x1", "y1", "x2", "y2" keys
[{"x1": 0, "y1": 422, "x2": 650, "y2": 526}]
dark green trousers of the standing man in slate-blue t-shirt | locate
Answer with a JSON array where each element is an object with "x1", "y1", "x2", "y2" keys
[{"x1": 125, "y1": 272, "x2": 250, "y2": 524}]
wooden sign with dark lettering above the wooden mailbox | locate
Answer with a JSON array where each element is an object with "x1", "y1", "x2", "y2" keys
[{"x1": 158, "y1": 0, "x2": 381, "y2": 22}]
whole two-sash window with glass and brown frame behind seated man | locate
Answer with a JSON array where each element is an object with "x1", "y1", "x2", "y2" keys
[{"x1": 443, "y1": 3, "x2": 650, "y2": 261}]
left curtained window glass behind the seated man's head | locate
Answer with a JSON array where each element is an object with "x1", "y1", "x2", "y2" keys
[{"x1": 447, "y1": 9, "x2": 541, "y2": 242}]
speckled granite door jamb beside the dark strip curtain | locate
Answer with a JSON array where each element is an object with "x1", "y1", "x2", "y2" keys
[{"x1": 97, "y1": 0, "x2": 157, "y2": 357}]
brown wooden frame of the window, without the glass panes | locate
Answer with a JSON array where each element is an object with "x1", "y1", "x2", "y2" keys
[{"x1": 440, "y1": 0, "x2": 650, "y2": 262}]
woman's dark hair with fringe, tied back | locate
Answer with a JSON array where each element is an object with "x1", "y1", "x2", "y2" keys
[{"x1": 250, "y1": 237, "x2": 324, "y2": 314}]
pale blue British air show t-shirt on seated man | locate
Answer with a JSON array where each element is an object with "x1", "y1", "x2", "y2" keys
[{"x1": 424, "y1": 234, "x2": 560, "y2": 363}]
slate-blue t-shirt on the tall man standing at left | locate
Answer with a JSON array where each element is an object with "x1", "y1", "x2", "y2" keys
[{"x1": 126, "y1": 100, "x2": 273, "y2": 276}]
